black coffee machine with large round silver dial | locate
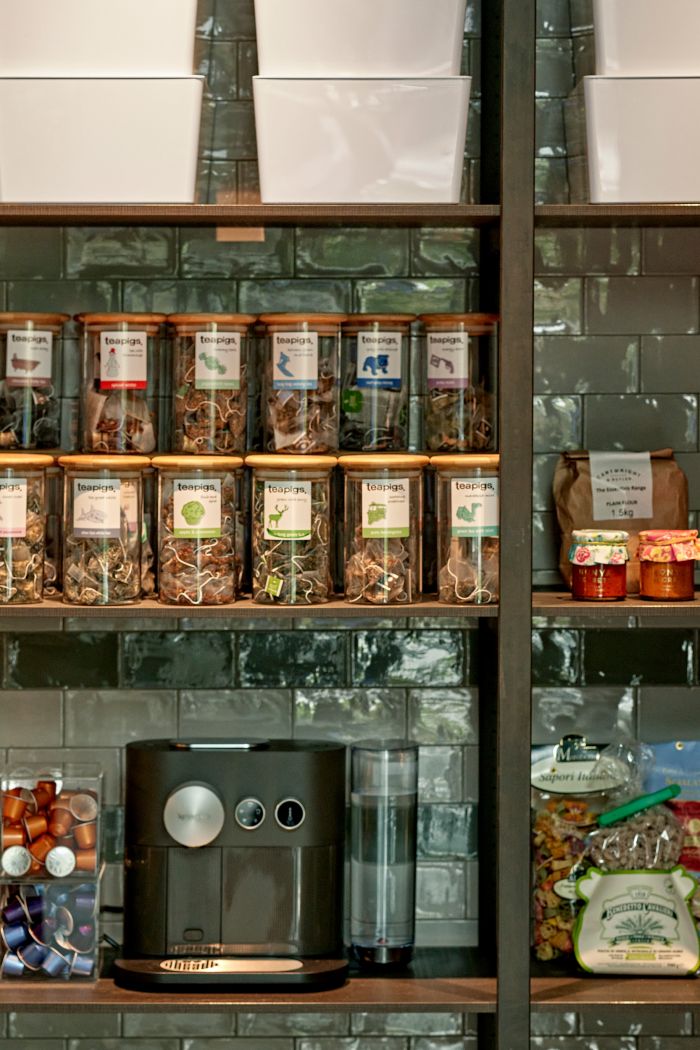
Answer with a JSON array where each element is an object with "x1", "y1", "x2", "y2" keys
[{"x1": 114, "y1": 740, "x2": 347, "y2": 990}]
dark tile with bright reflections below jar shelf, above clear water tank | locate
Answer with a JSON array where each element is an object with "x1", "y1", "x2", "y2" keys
[{"x1": 353, "y1": 630, "x2": 465, "y2": 688}]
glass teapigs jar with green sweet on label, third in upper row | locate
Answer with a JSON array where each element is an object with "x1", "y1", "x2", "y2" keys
[{"x1": 168, "y1": 314, "x2": 255, "y2": 454}]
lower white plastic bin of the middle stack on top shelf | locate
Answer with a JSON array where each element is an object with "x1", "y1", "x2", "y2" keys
[{"x1": 253, "y1": 77, "x2": 471, "y2": 204}]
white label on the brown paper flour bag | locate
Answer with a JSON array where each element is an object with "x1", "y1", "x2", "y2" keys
[{"x1": 589, "y1": 453, "x2": 654, "y2": 522}]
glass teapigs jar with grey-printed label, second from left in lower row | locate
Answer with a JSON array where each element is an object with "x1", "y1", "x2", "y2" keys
[{"x1": 59, "y1": 456, "x2": 150, "y2": 605}]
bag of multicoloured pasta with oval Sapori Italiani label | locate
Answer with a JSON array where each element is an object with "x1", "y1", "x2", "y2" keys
[{"x1": 531, "y1": 735, "x2": 650, "y2": 963}]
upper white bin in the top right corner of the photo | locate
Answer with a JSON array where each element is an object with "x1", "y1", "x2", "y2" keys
[{"x1": 593, "y1": 0, "x2": 700, "y2": 77}]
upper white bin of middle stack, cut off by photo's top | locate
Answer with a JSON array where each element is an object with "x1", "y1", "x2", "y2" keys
[{"x1": 255, "y1": 0, "x2": 466, "y2": 77}]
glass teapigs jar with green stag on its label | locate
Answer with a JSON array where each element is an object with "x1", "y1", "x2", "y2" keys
[{"x1": 246, "y1": 456, "x2": 337, "y2": 605}]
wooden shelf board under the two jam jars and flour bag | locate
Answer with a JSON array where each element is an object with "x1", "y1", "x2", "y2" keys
[{"x1": 532, "y1": 591, "x2": 700, "y2": 627}]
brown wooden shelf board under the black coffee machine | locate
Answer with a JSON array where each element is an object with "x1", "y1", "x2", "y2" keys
[{"x1": 0, "y1": 948, "x2": 496, "y2": 1013}]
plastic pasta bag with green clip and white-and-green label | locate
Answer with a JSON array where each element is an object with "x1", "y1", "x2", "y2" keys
[{"x1": 573, "y1": 784, "x2": 700, "y2": 975}]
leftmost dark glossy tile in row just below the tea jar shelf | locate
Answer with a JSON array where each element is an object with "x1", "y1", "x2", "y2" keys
[{"x1": 7, "y1": 631, "x2": 119, "y2": 689}]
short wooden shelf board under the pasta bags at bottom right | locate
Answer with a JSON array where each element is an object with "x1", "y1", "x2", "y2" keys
[{"x1": 532, "y1": 977, "x2": 700, "y2": 1011}]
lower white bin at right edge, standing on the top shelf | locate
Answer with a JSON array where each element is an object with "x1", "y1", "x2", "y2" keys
[{"x1": 584, "y1": 77, "x2": 700, "y2": 204}]
